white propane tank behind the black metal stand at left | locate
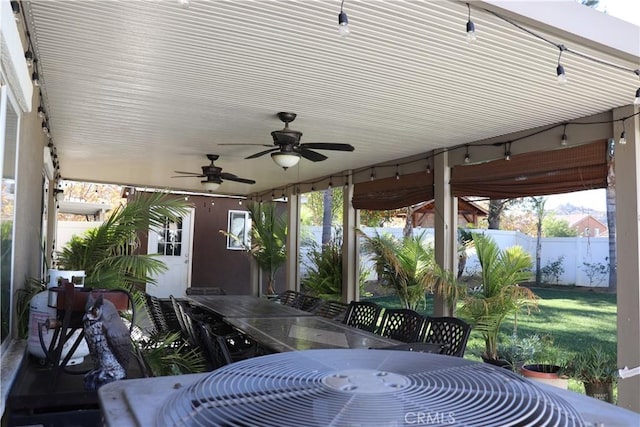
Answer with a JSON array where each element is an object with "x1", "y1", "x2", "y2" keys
[{"x1": 27, "y1": 269, "x2": 89, "y2": 365}]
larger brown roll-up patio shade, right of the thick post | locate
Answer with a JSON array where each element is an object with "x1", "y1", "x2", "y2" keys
[{"x1": 451, "y1": 140, "x2": 608, "y2": 199}]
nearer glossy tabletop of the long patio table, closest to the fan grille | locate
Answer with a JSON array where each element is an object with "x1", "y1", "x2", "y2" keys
[{"x1": 225, "y1": 316, "x2": 400, "y2": 352}]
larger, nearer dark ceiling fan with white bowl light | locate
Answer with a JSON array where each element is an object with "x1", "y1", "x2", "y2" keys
[{"x1": 219, "y1": 112, "x2": 354, "y2": 169}]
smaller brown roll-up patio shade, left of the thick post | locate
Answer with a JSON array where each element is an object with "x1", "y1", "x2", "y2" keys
[{"x1": 351, "y1": 172, "x2": 433, "y2": 211}]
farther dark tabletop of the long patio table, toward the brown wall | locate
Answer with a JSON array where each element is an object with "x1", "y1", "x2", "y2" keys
[{"x1": 186, "y1": 295, "x2": 313, "y2": 319}]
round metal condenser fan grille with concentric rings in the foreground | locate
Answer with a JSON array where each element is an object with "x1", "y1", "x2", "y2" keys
[{"x1": 158, "y1": 350, "x2": 584, "y2": 427}]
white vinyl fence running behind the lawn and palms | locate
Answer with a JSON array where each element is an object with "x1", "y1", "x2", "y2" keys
[{"x1": 300, "y1": 226, "x2": 609, "y2": 287}]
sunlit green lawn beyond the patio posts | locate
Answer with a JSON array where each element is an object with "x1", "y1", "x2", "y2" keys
[{"x1": 369, "y1": 288, "x2": 617, "y2": 393}]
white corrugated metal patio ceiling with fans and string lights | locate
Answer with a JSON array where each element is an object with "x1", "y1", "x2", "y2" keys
[{"x1": 29, "y1": 0, "x2": 639, "y2": 194}]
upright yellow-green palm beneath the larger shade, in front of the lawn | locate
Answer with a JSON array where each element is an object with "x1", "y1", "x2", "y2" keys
[{"x1": 460, "y1": 233, "x2": 537, "y2": 360}]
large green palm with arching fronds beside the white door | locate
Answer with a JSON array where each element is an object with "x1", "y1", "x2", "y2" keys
[{"x1": 58, "y1": 193, "x2": 188, "y2": 289}]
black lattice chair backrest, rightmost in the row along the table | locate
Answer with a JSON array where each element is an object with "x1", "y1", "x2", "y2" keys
[{"x1": 419, "y1": 317, "x2": 471, "y2": 357}]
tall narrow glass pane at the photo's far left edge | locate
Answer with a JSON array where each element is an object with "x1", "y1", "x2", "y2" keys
[{"x1": 0, "y1": 98, "x2": 18, "y2": 342}]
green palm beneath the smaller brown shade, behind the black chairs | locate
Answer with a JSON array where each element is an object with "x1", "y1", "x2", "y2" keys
[{"x1": 360, "y1": 232, "x2": 439, "y2": 310}]
